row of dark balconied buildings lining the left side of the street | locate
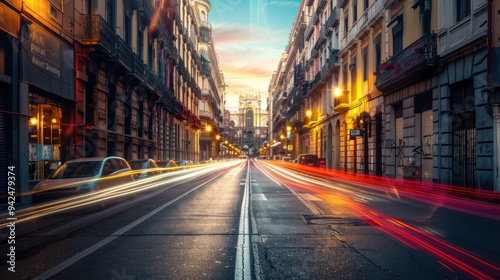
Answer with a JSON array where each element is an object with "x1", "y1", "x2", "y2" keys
[{"x1": 0, "y1": 0, "x2": 224, "y2": 202}]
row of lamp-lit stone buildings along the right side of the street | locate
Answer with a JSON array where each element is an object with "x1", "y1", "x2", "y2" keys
[{"x1": 269, "y1": 0, "x2": 499, "y2": 190}]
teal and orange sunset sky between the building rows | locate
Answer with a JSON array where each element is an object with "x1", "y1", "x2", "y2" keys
[{"x1": 209, "y1": 0, "x2": 300, "y2": 111}]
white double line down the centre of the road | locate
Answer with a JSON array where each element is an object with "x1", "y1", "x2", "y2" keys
[{"x1": 234, "y1": 163, "x2": 252, "y2": 279}]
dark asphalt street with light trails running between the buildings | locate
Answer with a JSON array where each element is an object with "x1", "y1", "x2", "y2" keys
[{"x1": 0, "y1": 159, "x2": 500, "y2": 279}]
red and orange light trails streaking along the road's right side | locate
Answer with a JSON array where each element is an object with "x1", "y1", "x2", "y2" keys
[{"x1": 259, "y1": 162, "x2": 500, "y2": 280}]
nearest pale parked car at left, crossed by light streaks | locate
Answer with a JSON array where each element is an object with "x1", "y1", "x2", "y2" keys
[{"x1": 33, "y1": 156, "x2": 134, "y2": 202}]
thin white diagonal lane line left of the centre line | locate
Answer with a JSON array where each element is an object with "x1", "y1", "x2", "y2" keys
[{"x1": 33, "y1": 166, "x2": 240, "y2": 280}]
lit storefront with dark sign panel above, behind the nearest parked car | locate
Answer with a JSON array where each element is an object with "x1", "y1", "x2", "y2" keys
[{"x1": 19, "y1": 21, "x2": 75, "y2": 184}]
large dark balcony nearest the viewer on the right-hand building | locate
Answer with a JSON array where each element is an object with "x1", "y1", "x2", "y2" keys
[{"x1": 373, "y1": 33, "x2": 439, "y2": 94}]
